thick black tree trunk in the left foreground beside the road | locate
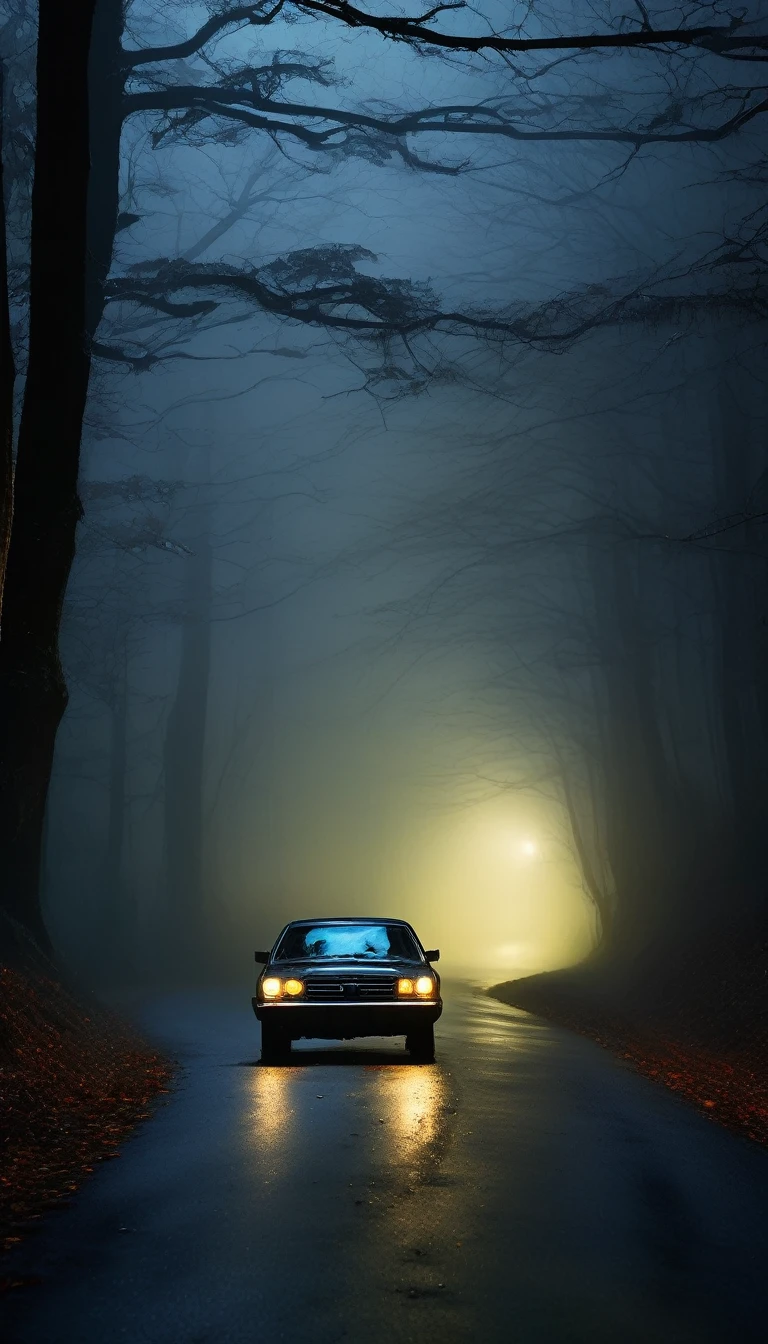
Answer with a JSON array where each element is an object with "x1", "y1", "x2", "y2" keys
[{"x1": 0, "y1": 0, "x2": 95, "y2": 962}]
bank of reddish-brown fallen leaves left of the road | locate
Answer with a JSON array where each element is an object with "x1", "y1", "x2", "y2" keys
[{"x1": 0, "y1": 966, "x2": 174, "y2": 1290}]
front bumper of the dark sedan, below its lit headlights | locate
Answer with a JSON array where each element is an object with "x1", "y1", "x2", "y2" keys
[{"x1": 252, "y1": 999, "x2": 443, "y2": 1040}]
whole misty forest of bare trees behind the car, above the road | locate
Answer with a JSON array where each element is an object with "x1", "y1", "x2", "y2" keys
[{"x1": 0, "y1": 0, "x2": 768, "y2": 1241}]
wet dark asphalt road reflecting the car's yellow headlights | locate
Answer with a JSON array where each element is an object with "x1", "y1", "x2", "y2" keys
[{"x1": 0, "y1": 986, "x2": 768, "y2": 1344}]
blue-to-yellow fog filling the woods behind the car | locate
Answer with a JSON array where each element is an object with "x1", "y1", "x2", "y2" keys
[{"x1": 4, "y1": 0, "x2": 768, "y2": 999}]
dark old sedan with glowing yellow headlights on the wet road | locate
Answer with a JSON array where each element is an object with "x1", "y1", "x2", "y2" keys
[{"x1": 252, "y1": 918, "x2": 443, "y2": 1063}]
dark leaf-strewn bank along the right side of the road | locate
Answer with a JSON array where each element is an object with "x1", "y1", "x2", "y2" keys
[{"x1": 487, "y1": 976, "x2": 768, "y2": 1145}]
